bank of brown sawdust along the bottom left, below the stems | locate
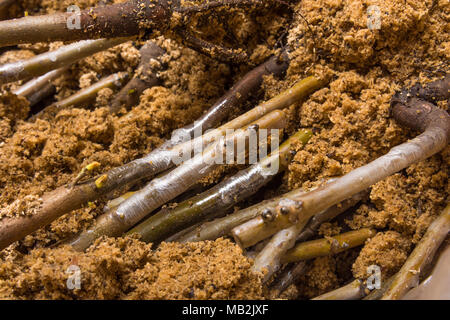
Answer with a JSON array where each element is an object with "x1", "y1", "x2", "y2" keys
[{"x1": 0, "y1": 238, "x2": 262, "y2": 299}]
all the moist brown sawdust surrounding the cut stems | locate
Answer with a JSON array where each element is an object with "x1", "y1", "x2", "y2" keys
[{"x1": 0, "y1": 0, "x2": 450, "y2": 299}]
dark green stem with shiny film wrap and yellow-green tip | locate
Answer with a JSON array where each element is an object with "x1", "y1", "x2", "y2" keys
[{"x1": 128, "y1": 130, "x2": 312, "y2": 243}]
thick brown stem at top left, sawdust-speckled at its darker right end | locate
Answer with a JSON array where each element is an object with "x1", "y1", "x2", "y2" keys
[{"x1": 0, "y1": 0, "x2": 171, "y2": 46}]
